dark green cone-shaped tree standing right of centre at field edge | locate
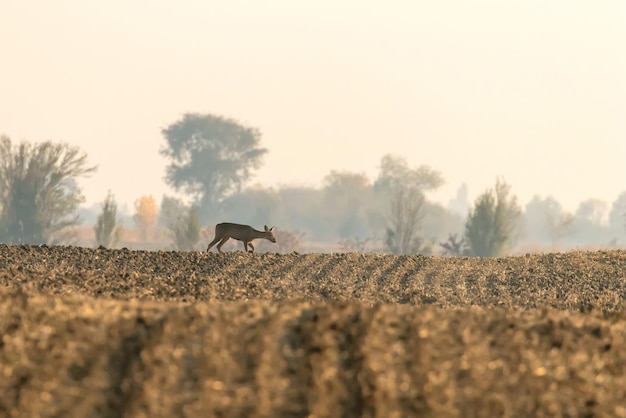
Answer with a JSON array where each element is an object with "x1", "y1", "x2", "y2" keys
[{"x1": 465, "y1": 179, "x2": 521, "y2": 257}]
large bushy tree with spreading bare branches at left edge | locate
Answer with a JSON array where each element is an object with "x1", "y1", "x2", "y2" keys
[{"x1": 0, "y1": 136, "x2": 96, "y2": 244}]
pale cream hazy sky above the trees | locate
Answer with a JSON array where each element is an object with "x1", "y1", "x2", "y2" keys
[{"x1": 0, "y1": 0, "x2": 626, "y2": 216}]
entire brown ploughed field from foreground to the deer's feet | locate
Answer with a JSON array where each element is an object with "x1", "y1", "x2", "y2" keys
[{"x1": 0, "y1": 245, "x2": 626, "y2": 417}]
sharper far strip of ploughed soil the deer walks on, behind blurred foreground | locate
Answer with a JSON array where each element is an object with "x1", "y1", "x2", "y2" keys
[{"x1": 0, "y1": 245, "x2": 626, "y2": 313}]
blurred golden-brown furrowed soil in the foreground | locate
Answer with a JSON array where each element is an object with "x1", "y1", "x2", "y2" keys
[{"x1": 0, "y1": 287, "x2": 626, "y2": 417}]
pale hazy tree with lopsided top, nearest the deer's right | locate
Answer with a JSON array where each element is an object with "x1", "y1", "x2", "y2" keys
[{"x1": 374, "y1": 155, "x2": 444, "y2": 254}]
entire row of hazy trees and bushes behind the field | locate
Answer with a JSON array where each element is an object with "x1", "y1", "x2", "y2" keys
[{"x1": 0, "y1": 113, "x2": 626, "y2": 257}]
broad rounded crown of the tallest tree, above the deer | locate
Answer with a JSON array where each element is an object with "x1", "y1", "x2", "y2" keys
[{"x1": 161, "y1": 113, "x2": 267, "y2": 220}]
